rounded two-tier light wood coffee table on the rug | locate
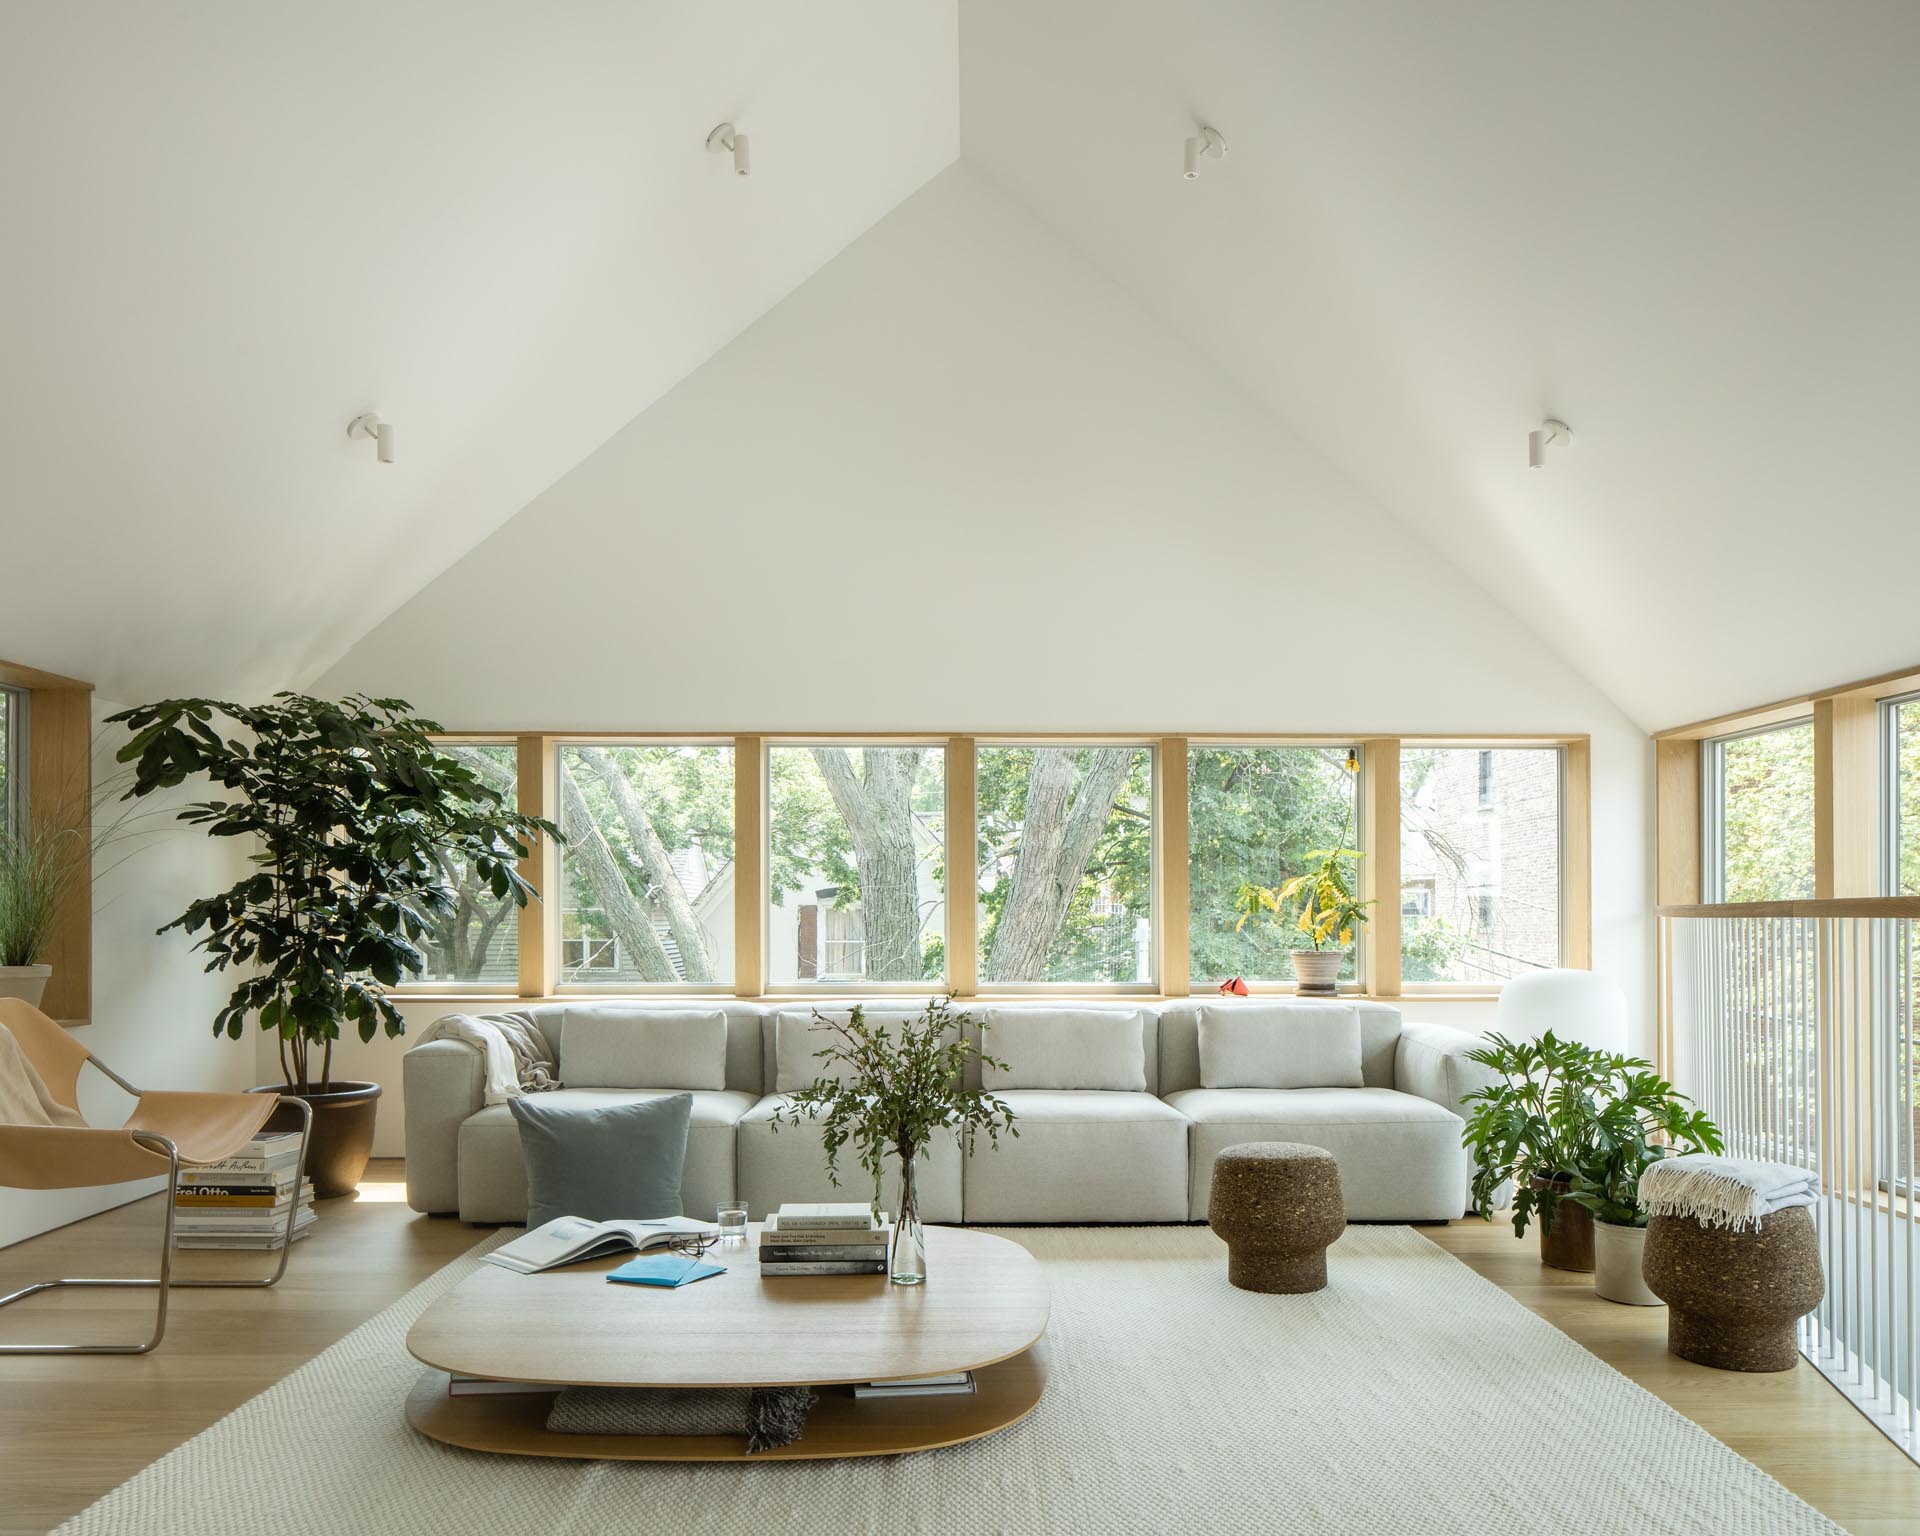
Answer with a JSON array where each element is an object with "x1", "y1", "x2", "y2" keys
[{"x1": 407, "y1": 1227, "x2": 1050, "y2": 1461}]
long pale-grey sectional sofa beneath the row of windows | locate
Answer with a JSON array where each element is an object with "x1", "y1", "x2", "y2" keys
[{"x1": 405, "y1": 998, "x2": 1492, "y2": 1223}]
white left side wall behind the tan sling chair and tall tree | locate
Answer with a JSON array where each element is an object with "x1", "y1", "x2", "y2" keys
[{"x1": 0, "y1": 701, "x2": 257, "y2": 1246}]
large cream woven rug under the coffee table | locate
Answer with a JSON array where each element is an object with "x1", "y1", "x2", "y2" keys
[{"x1": 61, "y1": 1227, "x2": 1839, "y2": 1536}]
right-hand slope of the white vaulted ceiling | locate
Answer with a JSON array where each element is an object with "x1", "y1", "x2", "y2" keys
[{"x1": 960, "y1": 0, "x2": 1920, "y2": 728}]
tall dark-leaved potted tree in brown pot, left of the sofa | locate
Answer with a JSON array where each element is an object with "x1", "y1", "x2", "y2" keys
[{"x1": 111, "y1": 693, "x2": 559, "y2": 1198}]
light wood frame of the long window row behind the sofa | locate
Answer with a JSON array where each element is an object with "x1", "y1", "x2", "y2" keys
[{"x1": 396, "y1": 730, "x2": 1589, "y2": 1004}]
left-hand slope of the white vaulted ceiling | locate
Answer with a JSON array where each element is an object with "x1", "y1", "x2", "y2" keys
[{"x1": 0, "y1": 0, "x2": 958, "y2": 699}]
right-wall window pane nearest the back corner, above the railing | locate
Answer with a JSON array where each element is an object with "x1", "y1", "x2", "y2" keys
[{"x1": 1701, "y1": 720, "x2": 1814, "y2": 900}]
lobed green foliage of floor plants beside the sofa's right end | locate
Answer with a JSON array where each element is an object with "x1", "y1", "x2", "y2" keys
[{"x1": 1461, "y1": 1031, "x2": 1722, "y2": 1235}]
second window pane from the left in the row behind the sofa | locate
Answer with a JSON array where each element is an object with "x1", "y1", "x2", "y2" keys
[{"x1": 559, "y1": 743, "x2": 733, "y2": 985}]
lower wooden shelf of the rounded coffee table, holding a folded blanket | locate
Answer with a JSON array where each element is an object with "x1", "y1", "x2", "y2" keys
[{"x1": 407, "y1": 1340, "x2": 1046, "y2": 1461}]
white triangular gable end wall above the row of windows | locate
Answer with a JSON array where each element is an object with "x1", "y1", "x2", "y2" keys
[{"x1": 319, "y1": 165, "x2": 1651, "y2": 1113}]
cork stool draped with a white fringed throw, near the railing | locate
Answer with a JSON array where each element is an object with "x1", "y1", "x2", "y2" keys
[{"x1": 1642, "y1": 1206, "x2": 1826, "y2": 1371}]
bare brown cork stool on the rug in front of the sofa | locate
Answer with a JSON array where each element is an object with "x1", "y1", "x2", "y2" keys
[{"x1": 1206, "y1": 1140, "x2": 1346, "y2": 1296}]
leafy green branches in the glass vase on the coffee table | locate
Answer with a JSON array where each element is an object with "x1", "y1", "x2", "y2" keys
[{"x1": 774, "y1": 996, "x2": 1020, "y2": 1217}]
